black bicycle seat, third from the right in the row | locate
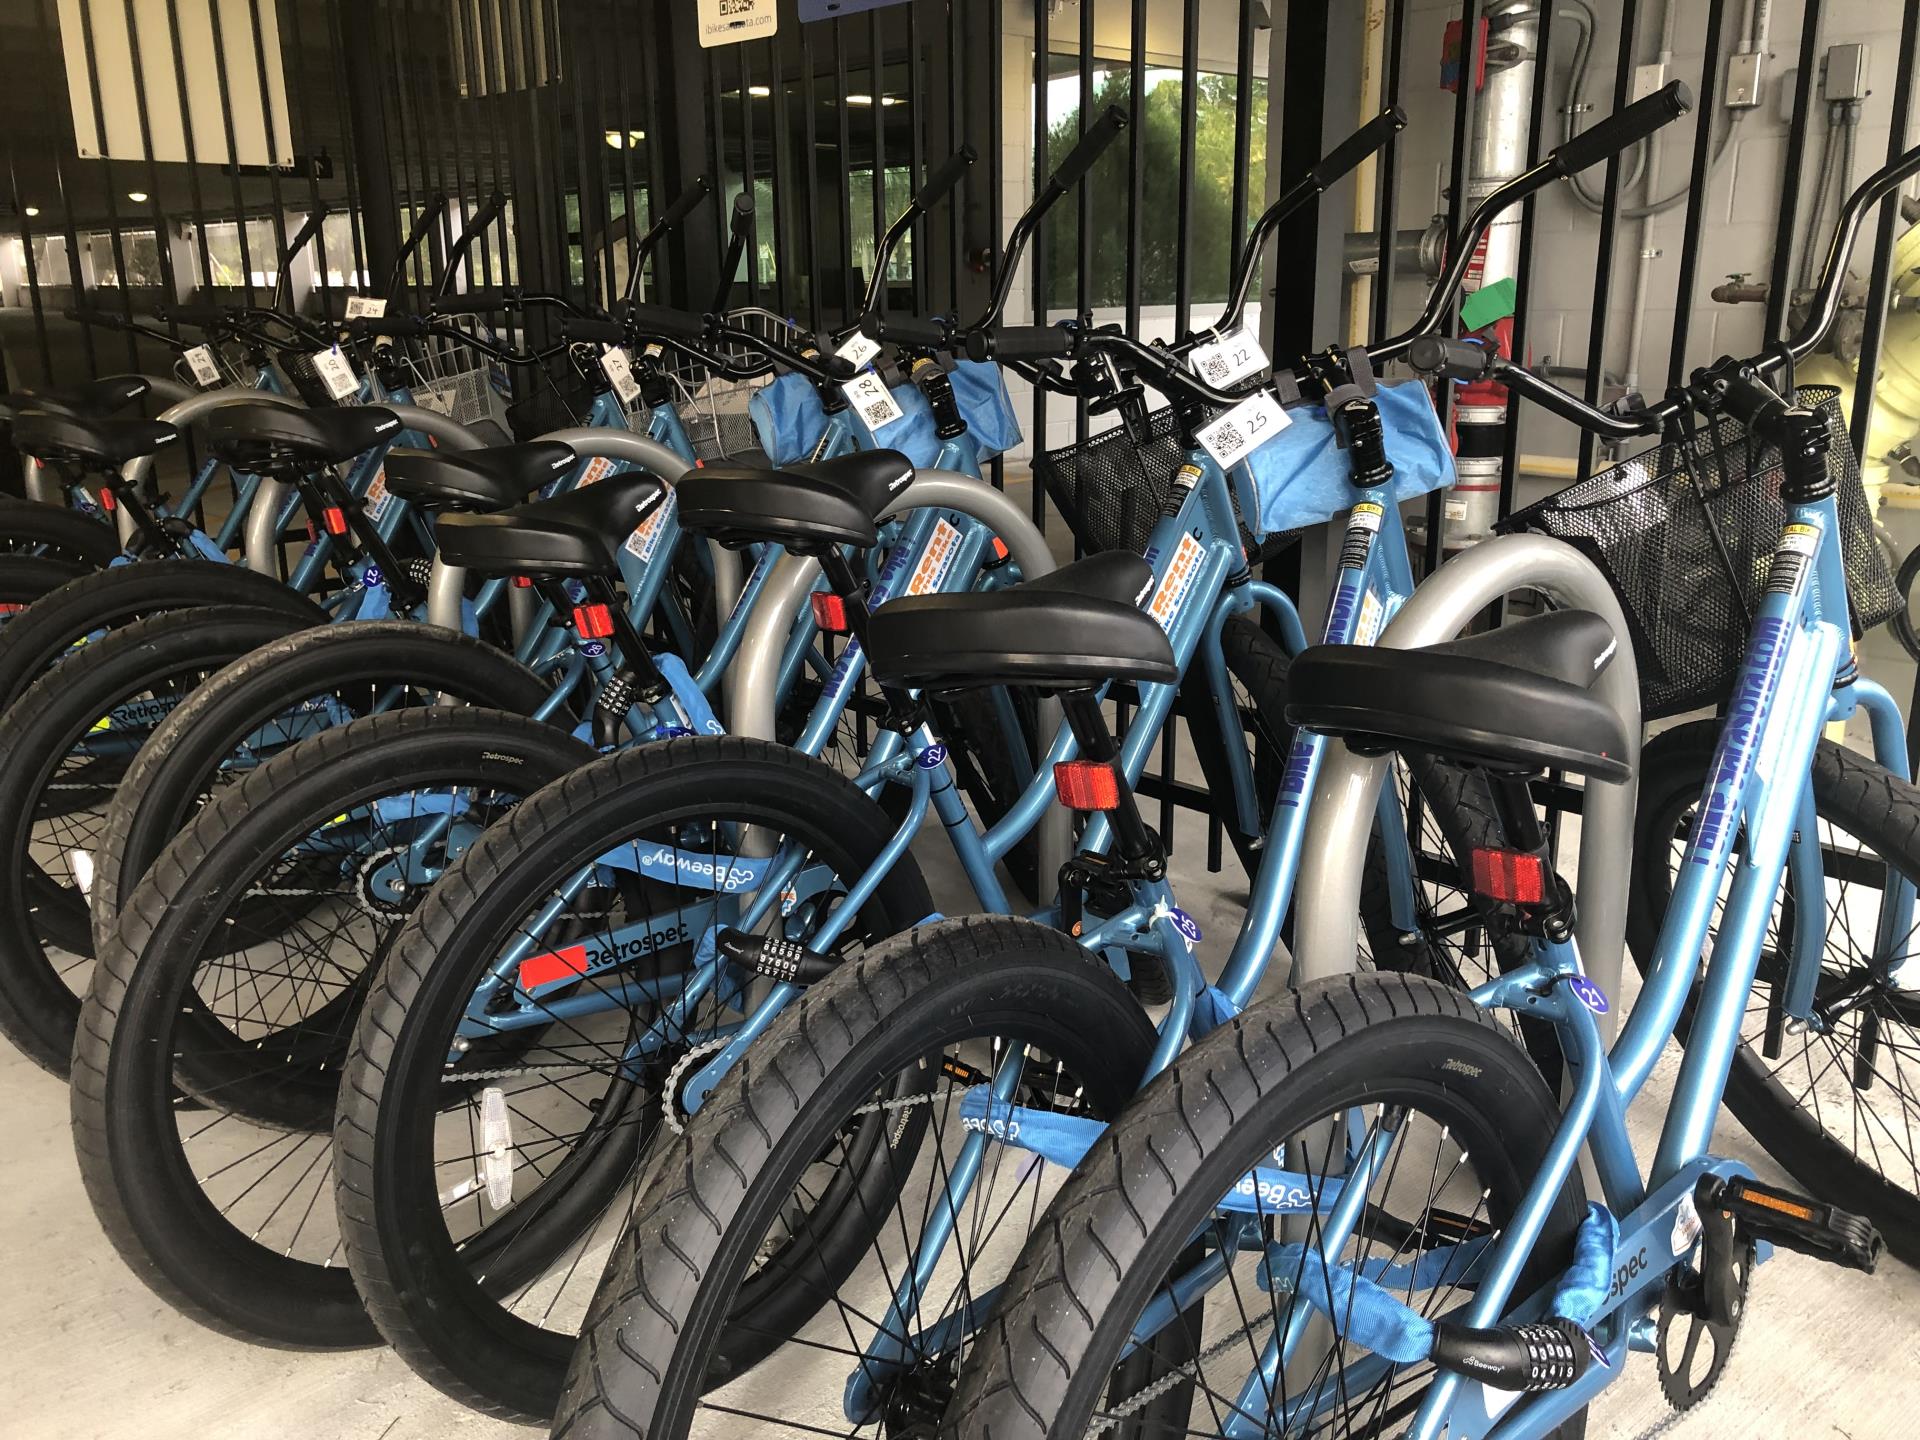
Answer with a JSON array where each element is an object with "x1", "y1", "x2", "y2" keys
[{"x1": 680, "y1": 449, "x2": 914, "y2": 555}]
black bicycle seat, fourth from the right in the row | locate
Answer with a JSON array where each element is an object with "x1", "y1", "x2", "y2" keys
[{"x1": 434, "y1": 470, "x2": 668, "y2": 576}]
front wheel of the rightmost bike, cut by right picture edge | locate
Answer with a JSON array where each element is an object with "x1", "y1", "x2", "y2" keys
[{"x1": 1628, "y1": 720, "x2": 1920, "y2": 1263}]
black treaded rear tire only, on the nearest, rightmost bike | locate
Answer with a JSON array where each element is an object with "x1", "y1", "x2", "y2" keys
[{"x1": 941, "y1": 972, "x2": 1584, "y2": 1440}]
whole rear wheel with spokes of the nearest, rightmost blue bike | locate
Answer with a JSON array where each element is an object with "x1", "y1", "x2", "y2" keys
[{"x1": 939, "y1": 975, "x2": 1584, "y2": 1440}]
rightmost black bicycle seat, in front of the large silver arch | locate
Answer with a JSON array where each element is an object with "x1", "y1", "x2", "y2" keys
[{"x1": 1286, "y1": 611, "x2": 1632, "y2": 783}]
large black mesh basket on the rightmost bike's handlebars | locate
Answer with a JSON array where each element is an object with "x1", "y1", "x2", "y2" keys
[{"x1": 1500, "y1": 386, "x2": 1899, "y2": 720}]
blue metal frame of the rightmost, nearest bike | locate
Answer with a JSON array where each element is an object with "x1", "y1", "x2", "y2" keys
[{"x1": 1227, "y1": 497, "x2": 1914, "y2": 1440}]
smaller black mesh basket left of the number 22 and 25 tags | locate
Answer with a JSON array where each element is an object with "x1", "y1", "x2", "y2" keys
[{"x1": 1033, "y1": 407, "x2": 1294, "y2": 563}]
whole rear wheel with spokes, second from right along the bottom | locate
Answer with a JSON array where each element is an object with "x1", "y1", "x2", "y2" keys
[{"x1": 553, "y1": 918, "x2": 1154, "y2": 1440}]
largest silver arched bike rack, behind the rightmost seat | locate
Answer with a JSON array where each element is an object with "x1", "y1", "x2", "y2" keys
[{"x1": 1290, "y1": 536, "x2": 1640, "y2": 1039}]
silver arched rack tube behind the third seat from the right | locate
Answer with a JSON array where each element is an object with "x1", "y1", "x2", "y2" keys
[{"x1": 728, "y1": 470, "x2": 1071, "y2": 904}]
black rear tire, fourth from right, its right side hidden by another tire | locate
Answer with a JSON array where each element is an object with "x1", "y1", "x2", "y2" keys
[{"x1": 71, "y1": 707, "x2": 591, "y2": 1350}]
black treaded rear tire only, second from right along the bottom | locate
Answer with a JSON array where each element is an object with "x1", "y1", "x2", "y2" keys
[{"x1": 553, "y1": 916, "x2": 1154, "y2": 1440}]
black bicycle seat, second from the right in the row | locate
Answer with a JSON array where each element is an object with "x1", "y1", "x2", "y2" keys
[{"x1": 868, "y1": 551, "x2": 1181, "y2": 691}]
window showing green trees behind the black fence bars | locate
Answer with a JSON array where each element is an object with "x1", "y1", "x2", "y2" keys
[{"x1": 1043, "y1": 56, "x2": 1267, "y2": 309}]
